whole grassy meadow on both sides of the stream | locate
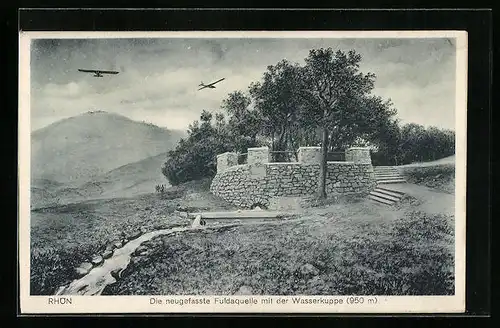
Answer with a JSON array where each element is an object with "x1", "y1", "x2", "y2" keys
[{"x1": 31, "y1": 177, "x2": 454, "y2": 295}]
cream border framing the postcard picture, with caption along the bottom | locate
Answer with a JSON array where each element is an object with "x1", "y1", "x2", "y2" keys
[{"x1": 18, "y1": 31, "x2": 467, "y2": 314}]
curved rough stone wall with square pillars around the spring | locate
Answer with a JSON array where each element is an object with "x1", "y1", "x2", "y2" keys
[{"x1": 210, "y1": 147, "x2": 375, "y2": 208}]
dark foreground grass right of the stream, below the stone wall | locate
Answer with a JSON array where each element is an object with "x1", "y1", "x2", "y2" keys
[{"x1": 105, "y1": 202, "x2": 454, "y2": 295}]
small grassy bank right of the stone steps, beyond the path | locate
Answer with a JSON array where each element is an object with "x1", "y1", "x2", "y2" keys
[{"x1": 399, "y1": 164, "x2": 455, "y2": 194}]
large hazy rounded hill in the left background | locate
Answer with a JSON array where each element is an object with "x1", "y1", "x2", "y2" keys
[{"x1": 31, "y1": 111, "x2": 182, "y2": 184}]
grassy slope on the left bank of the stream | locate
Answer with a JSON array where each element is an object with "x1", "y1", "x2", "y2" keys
[{"x1": 30, "y1": 181, "x2": 234, "y2": 295}]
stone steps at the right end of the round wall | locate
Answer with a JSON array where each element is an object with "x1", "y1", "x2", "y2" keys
[{"x1": 368, "y1": 166, "x2": 406, "y2": 205}]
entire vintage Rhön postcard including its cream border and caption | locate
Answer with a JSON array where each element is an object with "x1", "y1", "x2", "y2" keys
[{"x1": 18, "y1": 31, "x2": 467, "y2": 314}]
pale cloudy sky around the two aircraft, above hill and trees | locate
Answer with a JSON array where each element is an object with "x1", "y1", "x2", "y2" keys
[{"x1": 30, "y1": 38, "x2": 456, "y2": 130}]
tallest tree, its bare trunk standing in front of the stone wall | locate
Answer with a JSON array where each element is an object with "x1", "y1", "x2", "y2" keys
[{"x1": 299, "y1": 48, "x2": 375, "y2": 198}]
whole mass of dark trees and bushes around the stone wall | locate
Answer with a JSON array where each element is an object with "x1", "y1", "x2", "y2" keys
[{"x1": 162, "y1": 48, "x2": 454, "y2": 188}]
